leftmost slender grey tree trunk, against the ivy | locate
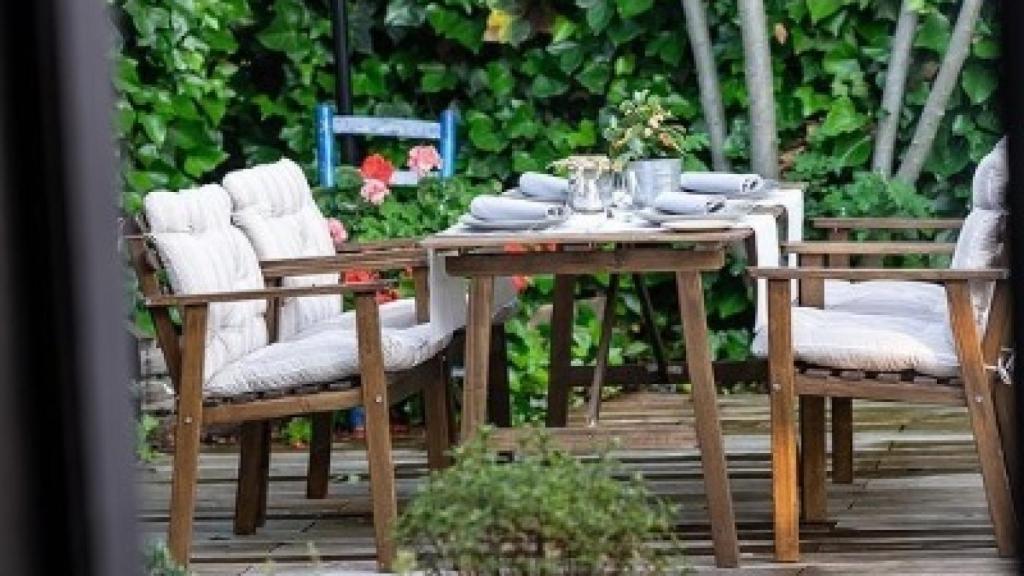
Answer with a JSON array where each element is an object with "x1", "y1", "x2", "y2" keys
[{"x1": 681, "y1": 0, "x2": 731, "y2": 172}]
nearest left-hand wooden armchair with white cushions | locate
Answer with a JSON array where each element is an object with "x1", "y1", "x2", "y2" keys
[{"x1": 127, "y1": 186, "x2": 449, "y2": 569}]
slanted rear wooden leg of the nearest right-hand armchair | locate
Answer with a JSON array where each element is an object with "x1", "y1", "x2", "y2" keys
[{"x1": 946, "y1": 281, "x2": 1017, "y2": 557}]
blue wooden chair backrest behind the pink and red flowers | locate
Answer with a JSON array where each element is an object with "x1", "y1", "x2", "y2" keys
[{"x1": 316, "y1": 104, "x2": 456, "y2": 188}]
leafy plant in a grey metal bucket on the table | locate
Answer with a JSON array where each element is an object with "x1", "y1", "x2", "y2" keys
[{"x1": 604, "y1": 90, "x2": 705, "y2": 207}]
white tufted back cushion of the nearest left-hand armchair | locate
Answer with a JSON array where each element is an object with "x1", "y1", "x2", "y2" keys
[{"x1": 143, "y1": 184, "x2": 267, "y2": 380}]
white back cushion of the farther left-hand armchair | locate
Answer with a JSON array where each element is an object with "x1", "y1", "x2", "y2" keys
[{"x1": 223, "y1": 158, "x2": 341, "y2": 340}]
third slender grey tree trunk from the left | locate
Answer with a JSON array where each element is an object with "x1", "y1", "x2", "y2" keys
[{"x1": 871, "y1": 0, "x2": 918, "y2": 177}]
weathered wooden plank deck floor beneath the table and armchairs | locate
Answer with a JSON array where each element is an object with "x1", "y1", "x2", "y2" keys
[{"x1": 139, "y1": 394, "x2": 1016, "y2": 576}]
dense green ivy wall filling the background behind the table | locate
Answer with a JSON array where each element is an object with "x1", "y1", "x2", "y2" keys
[{"x1": 110, "y1": 0, "x2": 1001, "y2": 419}]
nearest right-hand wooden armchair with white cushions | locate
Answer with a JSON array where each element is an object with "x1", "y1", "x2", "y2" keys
[{"x1": 751, "y1": 139, "x2": 1017, "y2": 561}]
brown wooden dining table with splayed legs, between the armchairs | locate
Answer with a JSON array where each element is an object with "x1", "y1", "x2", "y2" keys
[{"x1": 422, "y1": 227, "x2": 765, "y2": 568}]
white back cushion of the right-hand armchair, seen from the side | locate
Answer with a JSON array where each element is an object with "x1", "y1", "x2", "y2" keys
[{"x1": 950, "y1": 138, "x2": 1009, "y2": 323}]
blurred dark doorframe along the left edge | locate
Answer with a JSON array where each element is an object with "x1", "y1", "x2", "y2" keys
[{"x1": 0, "y1": 0, "x2": 140, "y2": 576}]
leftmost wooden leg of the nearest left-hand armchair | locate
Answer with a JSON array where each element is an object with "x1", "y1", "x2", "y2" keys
[{"x1": 167, "y1": 305, "x2": 207, "y2": 567}]
